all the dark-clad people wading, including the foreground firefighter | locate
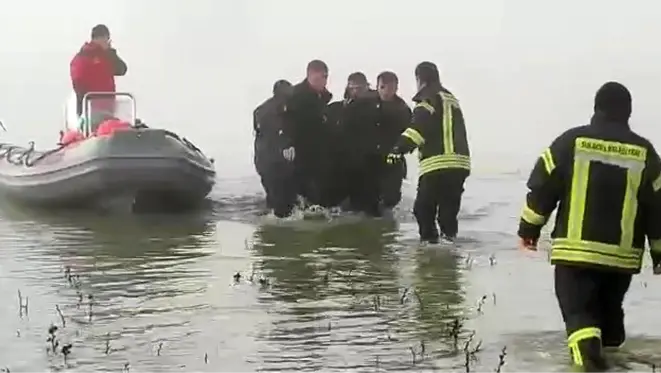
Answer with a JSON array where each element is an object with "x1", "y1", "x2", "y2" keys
[{"x1": 254, "y1": 60, "x2": 661, "y2": 372}]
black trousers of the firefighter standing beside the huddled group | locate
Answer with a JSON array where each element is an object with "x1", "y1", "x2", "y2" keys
[{"x1": 413, "y1": 169, "x2": 469, "y2": 242}]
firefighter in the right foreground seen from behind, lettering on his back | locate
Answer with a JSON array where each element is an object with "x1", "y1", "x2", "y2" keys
[{"x1": 518, "y1": 82, "x2": 661, "y2": 372}]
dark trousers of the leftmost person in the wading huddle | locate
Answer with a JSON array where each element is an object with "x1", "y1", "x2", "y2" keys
[{"x1": 257, "y1": 162, "x2": 297, "y2": 218}]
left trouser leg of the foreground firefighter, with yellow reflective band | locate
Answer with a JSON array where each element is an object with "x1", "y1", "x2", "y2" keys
[{"x1": 555, "y1": 265, "x2": 608, "y2": 372}]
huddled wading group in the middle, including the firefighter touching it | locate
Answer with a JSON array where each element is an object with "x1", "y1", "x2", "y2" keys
[{"x1": 253, "y1": 60, "x2": 470, "y2": 243}]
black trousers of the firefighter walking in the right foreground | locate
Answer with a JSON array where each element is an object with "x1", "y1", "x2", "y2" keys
[{"x1": 555, "y1": 264, "x2": 633, "y2": 371}]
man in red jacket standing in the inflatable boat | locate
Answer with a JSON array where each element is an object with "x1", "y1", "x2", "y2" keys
[{"x1": 70, "y1": 25, "x2": 127, "y2": 126}]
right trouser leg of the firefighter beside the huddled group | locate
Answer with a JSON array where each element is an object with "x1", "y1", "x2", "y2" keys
[{"x1": 437, "y1": 170, "x2": 468, "y2": 238}]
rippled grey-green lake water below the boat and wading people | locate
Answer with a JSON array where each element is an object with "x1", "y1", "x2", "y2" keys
[{"x1": 0, "y1": 186, "x2": 661, "y2": 372}]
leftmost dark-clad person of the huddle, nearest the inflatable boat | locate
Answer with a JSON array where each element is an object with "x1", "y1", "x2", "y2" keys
[{"x1": 253, "y1": 80, "x2": 296, "y2": 218}]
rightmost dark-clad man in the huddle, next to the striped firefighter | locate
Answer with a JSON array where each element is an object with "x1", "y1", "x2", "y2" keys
[{"x1": 376, "y1": 71, "x2": 411, "y2": 209}]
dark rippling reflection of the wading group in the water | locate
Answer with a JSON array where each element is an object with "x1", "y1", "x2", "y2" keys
[{"x1": 249, "y1": 221, "x2": 470, "y2": 372}]
